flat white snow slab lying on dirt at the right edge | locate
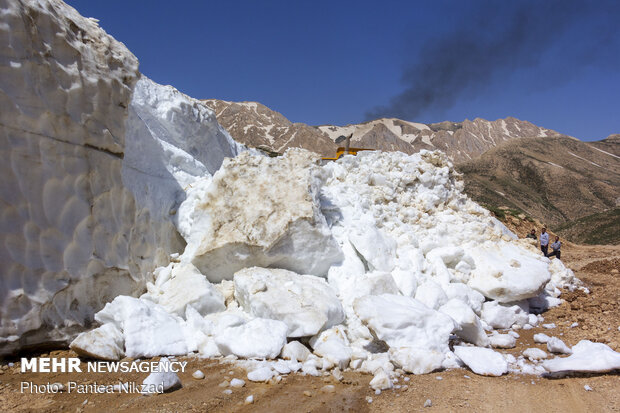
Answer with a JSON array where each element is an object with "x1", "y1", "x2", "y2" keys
[{"x1": 542, "y1": 340, "x2": 620, "y2": 373}]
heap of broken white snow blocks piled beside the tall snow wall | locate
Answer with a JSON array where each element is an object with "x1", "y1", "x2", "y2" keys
[{"x1": 72, "y1": 149, "x2": 592, "y2": 382}]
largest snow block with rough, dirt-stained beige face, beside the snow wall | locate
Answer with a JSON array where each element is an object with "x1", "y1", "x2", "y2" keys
[{"x1": 184, "y1": 149, "x2": 343, "y2": 282}]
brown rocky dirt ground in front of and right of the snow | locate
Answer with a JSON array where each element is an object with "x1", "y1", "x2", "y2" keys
[{"x1": 0, "y1": 244, "x2": 620, "y2": 412}]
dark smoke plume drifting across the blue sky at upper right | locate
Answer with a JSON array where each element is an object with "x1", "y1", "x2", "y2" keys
[{"x1": 366, "y1": 0, "x2": 620, "y2": 120}]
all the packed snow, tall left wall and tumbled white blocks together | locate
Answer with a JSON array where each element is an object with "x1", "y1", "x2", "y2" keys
[{"x1": 0, "y1": 0, "x2": 619, "y2": 390}]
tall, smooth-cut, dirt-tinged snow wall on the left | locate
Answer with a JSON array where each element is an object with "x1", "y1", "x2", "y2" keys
[{"x1": 0, "y1": 0, "x2": 239, "y2": 355}]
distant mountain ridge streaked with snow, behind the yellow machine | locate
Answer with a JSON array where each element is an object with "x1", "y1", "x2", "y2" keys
[{"x1": 204, "y1": 99, "x2": 564, "y2": 163}]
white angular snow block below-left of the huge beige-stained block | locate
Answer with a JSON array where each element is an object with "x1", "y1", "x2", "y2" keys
[{"x1": 148, "y1": 263, "x2": 226, "y2": 316}]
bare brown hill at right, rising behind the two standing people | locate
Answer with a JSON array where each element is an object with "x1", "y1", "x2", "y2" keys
[{"x1": 457, "y1": 137, "x2": 620, "y2": 227}]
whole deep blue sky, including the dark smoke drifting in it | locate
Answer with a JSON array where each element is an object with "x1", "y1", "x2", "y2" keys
[{"x1": 68, "y1": 0, "x2": 620, "y2": 140}]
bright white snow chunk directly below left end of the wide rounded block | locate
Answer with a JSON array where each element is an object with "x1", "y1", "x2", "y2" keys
[{"x1": 215, "y1": 318, "x2": 288, "y2": 359}]
